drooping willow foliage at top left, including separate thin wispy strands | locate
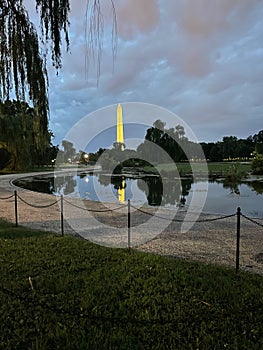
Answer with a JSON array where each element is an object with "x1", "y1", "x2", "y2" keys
[{"x1": 0, "y1": 0, "x2": 116, "y2": 125}]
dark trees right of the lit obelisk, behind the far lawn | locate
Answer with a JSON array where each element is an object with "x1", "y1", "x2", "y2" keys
[{"x1": 137, "y1": 120, "x2": 263, "y2": 163}]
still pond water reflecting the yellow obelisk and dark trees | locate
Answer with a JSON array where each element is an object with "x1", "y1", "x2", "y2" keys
[{"x1": 15, "y1": 173, "x2": 263, "y2": 216}]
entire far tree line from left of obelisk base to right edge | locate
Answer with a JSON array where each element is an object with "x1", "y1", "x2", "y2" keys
[{"x1": 85, "y1": 119, "x2": 263, "y2": 173}]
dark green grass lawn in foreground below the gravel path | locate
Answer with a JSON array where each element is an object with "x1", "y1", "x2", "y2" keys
[{"x1": 0, "y1": 222, "x2": 263, "y2": 350}]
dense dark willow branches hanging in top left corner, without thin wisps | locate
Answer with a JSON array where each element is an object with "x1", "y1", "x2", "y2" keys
[{"x1": 0, "y1": 0, "x2": 70, "y2": 124}]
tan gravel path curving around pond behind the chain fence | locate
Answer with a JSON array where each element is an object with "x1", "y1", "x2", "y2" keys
[{"x1": 0, "y1": 170, "x2": 263, "y2": 274}]
